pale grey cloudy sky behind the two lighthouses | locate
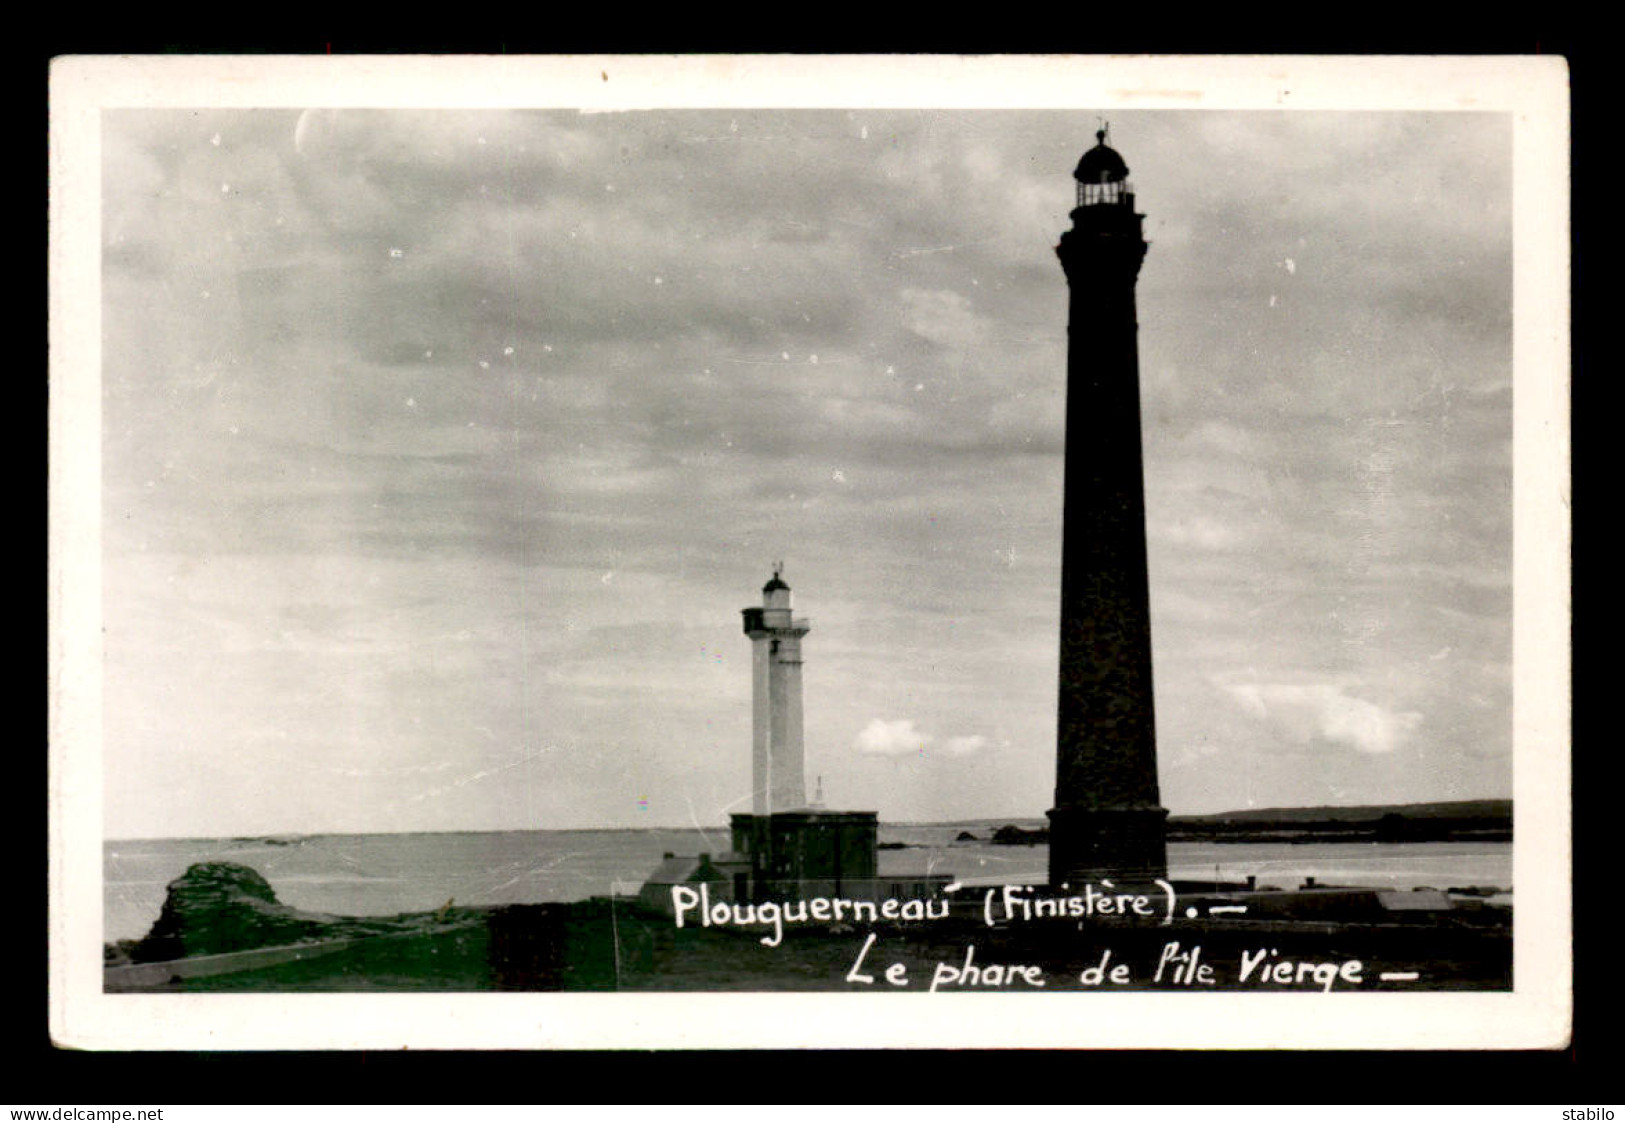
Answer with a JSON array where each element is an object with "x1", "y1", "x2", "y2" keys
[{"x1": 102, "y1": 109, "x2": 1511, "y2": 839}]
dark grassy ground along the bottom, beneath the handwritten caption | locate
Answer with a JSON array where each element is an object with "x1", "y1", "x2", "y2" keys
[{"x1": 114, "y1": 899, "x2": 1511, "y2": 993}]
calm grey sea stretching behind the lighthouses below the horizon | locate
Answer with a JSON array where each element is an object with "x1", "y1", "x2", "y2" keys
[{"x1": 102, "y1": 822, "x2": 1513, "y2": 943}]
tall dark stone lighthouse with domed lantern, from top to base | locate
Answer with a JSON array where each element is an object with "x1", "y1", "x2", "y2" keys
[{"x1": 1050, "y1": 130, "x2": 1168, "y2": 886}]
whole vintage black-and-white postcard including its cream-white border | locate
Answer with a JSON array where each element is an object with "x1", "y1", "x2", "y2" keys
[{"x1": 50, "y1": 57, "x2": 1571, "y2": 1048}]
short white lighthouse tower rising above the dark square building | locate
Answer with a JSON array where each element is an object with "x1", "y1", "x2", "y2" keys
[{"x1": 739, "y1": 564, "x2": 813, "y2": 816}]
